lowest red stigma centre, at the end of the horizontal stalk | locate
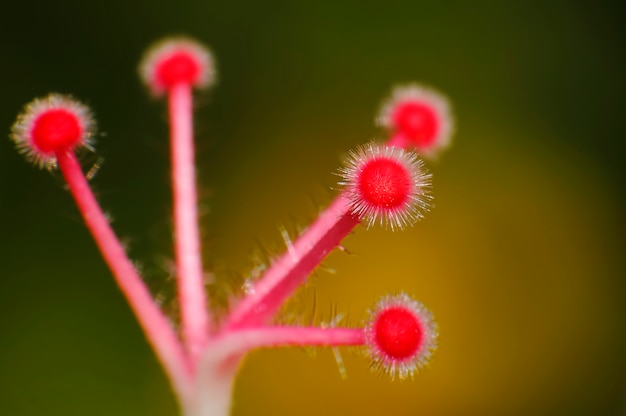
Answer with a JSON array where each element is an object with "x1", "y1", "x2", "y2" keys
[{"x1": 374, "y1": 306, "x2": 423, "y2": 360}]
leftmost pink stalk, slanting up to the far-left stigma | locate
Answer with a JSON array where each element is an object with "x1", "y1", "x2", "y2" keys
[{"x1": 56, "y1": 150, "x2": 193, "y2": 403}]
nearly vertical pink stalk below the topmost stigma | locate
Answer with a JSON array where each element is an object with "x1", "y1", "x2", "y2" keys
[{"x1": 169, "y1": 82, "x2": 209, "y2": 362}]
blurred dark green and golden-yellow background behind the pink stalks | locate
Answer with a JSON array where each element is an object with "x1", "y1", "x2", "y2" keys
[{"x1": 0, "y1": 0, "x2": 626, "y2": 416}]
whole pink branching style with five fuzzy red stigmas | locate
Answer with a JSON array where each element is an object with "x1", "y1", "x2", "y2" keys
[{"x1": 11, "y1": 38, "x2": 452, "y2": 416}]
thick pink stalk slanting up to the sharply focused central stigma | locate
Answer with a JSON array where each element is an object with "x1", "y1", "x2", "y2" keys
[{"x1": 225, "y1": 193, "x2": 360, "y2": 329}]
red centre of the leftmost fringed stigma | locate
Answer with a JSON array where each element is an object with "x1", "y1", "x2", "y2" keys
[{"x1": 31, "y1": 108, "x2": 83, "y2": 153}]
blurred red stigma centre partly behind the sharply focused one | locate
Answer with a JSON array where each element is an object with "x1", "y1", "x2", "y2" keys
[{"x1": 392, "y1": 101, "x2": 439, "y2": 147}]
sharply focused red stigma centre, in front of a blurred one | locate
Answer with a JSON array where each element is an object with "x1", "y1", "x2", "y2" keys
[{"x1": 357, "y1": 158, "x2": 411, "y2": 208}]
